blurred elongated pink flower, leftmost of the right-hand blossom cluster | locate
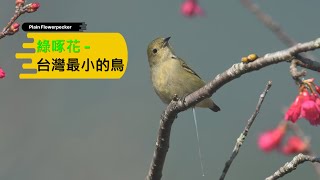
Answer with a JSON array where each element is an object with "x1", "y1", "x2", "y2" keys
[{"x1": 258, "y1": 123, "x2": 286, "y2": 152}]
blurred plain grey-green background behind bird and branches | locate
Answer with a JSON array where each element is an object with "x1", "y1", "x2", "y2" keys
[{"x1": 0, "y1": 0, "x2": 320, "y2": 180}]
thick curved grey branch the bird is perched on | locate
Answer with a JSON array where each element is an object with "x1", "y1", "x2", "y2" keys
[{"x1": 146, "y1": 38, "x2": 320, "y2": 180}]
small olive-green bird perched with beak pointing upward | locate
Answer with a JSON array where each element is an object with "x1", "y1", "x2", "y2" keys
[{"x1": 147, "y1": 37, "x2": 220, "y2": 112}]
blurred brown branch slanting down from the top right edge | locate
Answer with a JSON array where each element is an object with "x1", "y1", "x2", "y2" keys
[{"x1": 240, "y1": 0, "x2": 317, "y2": 60}]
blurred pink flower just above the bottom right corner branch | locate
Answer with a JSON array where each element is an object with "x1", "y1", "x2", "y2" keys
[{"x1": 281, "y1": 136, "x2": 308, "y2": 155}]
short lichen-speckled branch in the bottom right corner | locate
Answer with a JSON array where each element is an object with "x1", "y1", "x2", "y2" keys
[{"x1": 266, "y1": 153, "x2": 320, "y2": 180}]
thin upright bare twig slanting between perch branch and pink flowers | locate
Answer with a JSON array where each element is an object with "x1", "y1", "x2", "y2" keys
[{"x1": 219, "y1": 81, "x2": 272, "y2": 180}]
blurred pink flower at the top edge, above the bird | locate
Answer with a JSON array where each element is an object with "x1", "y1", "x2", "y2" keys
[{"x1": 180, "y1": 0, "x2": 204, "y2": 17}]
